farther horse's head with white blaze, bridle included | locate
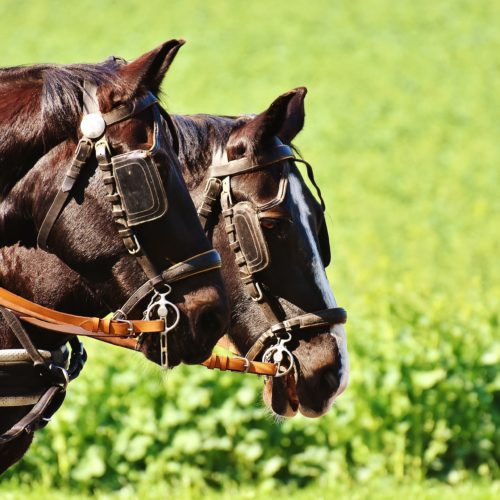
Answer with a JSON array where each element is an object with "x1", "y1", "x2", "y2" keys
[{"x1": 173, "y1": 87, "x2": 349, "y2": 417}]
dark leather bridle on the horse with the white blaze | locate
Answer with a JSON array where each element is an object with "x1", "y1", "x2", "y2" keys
[{"x1": 198, "y1": 138, "x2": 347, "y2": 377}]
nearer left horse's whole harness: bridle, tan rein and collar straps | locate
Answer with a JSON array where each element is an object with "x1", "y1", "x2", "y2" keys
[{"x1": 0, "y1": 82, "x2": 221, "y2": 449}]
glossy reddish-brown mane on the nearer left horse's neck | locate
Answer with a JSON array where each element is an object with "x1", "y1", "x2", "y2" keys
[{"x1": 0, "y1": 61, "x2": 123, "y2": 198}]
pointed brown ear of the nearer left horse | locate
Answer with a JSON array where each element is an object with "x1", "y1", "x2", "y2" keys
[{"x1": 107, "y1": 40, "x2": 186, "y2": 104}]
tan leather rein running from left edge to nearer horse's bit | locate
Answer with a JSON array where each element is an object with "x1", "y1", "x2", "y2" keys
[{"x1": 0, "y1": 287, "x2": 165, "y2": 337}]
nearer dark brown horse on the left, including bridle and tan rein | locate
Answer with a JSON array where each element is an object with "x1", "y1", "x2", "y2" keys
[{"x1": 0, "y1": 40, "x2": 229, "y2": 471}]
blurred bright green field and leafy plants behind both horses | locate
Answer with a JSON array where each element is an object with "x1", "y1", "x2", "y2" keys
[{"x1": 0, "y1": 0, "x2": 500, "y2": 498}]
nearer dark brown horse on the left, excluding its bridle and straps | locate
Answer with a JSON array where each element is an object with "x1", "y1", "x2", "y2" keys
[{"x1": 0, "y1": 40, "x2": 228, "y2": 470}]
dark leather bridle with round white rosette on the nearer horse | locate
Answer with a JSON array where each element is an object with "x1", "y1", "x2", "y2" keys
[{"x1": 33, "y1": 82, "x2": 221, "y2": 368}]
